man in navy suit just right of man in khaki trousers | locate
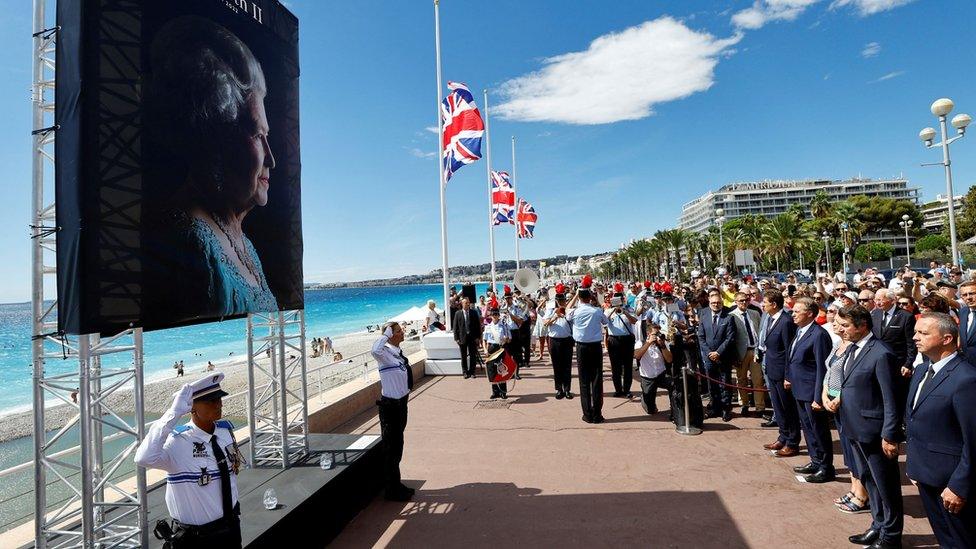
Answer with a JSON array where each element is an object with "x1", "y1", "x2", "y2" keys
[{"x1": 760, "y1": 289, "x2": 800, "y2": 457}]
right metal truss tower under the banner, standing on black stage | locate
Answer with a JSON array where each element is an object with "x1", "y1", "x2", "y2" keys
[{"x1": 247, "y1": 310, "x2": 309, "y2": 469}]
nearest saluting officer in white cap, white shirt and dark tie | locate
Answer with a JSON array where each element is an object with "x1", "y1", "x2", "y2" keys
[{"x1": 135, "y1": 372, "x2": 243, "y2": 549}]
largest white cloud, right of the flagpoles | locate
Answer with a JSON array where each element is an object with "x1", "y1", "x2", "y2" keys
[{"x1": 496, "y1": 17, "x2": 742, "y2": 124}]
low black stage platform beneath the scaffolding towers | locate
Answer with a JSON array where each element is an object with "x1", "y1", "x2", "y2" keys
[{"x1": 149, "y1": 434, "x2": 382, "y2": 547}]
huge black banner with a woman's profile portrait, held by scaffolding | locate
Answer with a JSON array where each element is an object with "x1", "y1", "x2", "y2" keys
[{"x1": 55, "y1": 0, "x2": 304, "y2": 334}]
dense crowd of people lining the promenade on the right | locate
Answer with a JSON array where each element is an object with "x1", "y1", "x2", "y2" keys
[{"x1": 434, "y1": 265, "x2": 976, "y2": 547}]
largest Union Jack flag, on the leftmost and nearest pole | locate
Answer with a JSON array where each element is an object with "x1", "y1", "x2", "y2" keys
[{"x1": 441, "y1": 81, "x2": 485, "y2": 183}]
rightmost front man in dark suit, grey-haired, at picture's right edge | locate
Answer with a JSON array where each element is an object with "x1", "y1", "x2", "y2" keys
[{"x1": 905, "y1": 310, "x2": 976, "y2": 547}]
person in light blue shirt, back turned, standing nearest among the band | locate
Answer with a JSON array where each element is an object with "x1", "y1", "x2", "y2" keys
[{"x1": 566, "y1": 275, "x2": 607, "y2": 423}]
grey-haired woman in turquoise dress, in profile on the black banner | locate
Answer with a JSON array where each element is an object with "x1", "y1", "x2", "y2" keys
[{"x1": 146, "y1": 16, "x2": 278, "y2": 322}]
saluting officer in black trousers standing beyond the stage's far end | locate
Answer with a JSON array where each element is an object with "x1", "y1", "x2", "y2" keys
[{"x1": 372, "y1": 322, "x2": 414, "y2": 501}]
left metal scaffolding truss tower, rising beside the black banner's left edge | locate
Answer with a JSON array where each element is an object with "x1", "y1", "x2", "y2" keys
[{"x1": 30, "y1": 0, "x2": 148, "y2": 548}]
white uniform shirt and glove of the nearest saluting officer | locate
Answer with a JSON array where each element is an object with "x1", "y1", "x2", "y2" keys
[{"x1": 135, "y1": 410, "x2": 241, "y2": 525}]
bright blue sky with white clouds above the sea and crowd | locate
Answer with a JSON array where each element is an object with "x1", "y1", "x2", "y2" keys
[{"x1": 0, "y1": 0, "x2": 976, "y2": 302}]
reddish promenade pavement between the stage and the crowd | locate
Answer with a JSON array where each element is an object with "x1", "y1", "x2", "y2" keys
[{"x1": 333, "y1": 354, "x2": 937, "y2": 549}]
